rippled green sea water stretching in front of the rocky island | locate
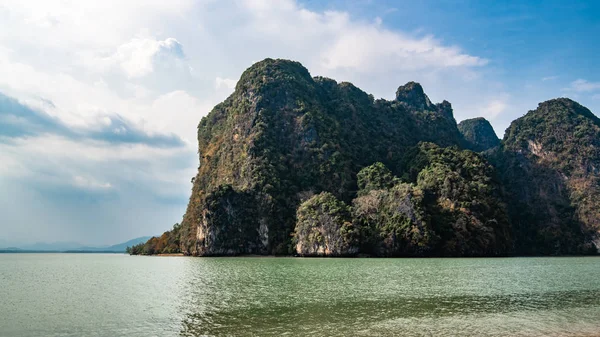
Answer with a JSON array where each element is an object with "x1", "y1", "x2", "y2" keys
[{"x1": 0, "y1": 254, "x2": 600, "y2": 336}]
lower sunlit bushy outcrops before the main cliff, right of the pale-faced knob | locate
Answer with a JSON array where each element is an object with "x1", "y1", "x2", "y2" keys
[{"x1": 353, "y1": 143, "x2": 511, "y2": 256}]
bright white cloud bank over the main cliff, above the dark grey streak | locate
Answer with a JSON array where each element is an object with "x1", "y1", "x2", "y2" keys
[{"x1": 0, "y1": 0, "x2": 487, "y2": 143}]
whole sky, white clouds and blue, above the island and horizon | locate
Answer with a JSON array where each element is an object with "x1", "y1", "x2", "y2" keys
[{"x1": 0, "y1": 0, "x2": 600, "y2": 246}]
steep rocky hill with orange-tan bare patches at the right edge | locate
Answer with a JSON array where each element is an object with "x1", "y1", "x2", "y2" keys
[{"x1": 490, "y1": 98, "x2": 600, "y2": 254}]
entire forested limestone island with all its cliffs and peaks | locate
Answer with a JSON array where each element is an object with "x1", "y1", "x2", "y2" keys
[{"x1": 128, "y1": 59, "x2": 600, "y2": 257}]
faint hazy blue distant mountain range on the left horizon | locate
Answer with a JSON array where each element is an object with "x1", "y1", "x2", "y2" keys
[{"x1": 0, "y1": 236, "x2": 151, "y2": 253}]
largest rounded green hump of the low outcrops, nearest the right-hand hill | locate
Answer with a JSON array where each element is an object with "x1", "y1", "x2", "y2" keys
[{"x1": 406, "y1": 144, "x2": 512, "y2": 256}]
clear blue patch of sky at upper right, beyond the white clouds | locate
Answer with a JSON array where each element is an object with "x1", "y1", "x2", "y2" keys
[{"x1": 304, "y1": 0, "x2": 600, "y2": 131}]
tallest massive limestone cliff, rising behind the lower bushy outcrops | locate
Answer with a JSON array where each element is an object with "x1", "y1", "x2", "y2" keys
[{"x1": 173, "y1": 59, "x2": 461, "y2": 255}]
